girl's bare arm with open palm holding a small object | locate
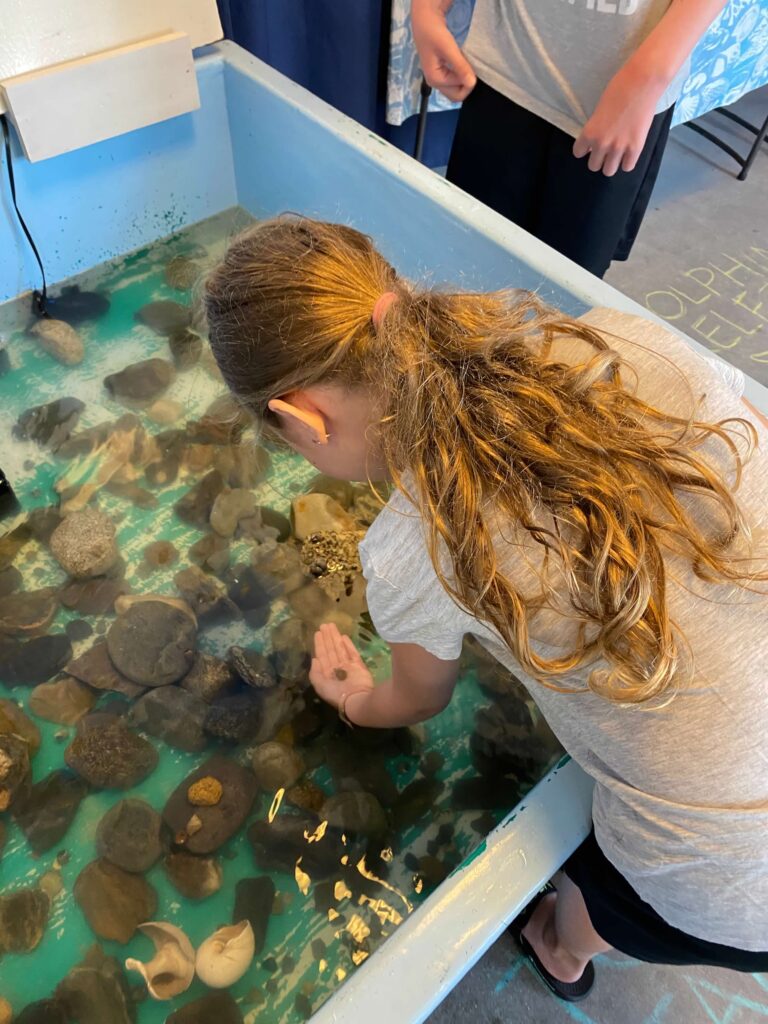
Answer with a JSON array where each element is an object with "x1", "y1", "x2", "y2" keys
[{"x1": 309, "y1": 625, "x2": 459, "y2": 729}]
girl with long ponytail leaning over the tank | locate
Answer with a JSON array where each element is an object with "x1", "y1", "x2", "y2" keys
[{"x1": 204, "y1": 217, "x2": 768, "y2": 998}]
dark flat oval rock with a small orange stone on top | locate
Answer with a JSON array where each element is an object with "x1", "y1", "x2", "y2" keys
[{"x1": 163, "y1": 755, "x2": 258, "y2": 854}]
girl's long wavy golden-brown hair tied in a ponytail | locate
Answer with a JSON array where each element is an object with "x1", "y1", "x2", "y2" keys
[{"x1": 203, "y1": 216, "x2": 768, "y2": 703}]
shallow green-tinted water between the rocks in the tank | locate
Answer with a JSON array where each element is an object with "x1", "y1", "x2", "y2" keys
[{"x1": 0, "y1": 211, "x2": 561, "y2": 1024}]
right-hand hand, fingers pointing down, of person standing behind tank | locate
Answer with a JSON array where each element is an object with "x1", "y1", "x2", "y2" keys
[{"x1": 573, "y1": 67, "x2": 659, "y2": 177}]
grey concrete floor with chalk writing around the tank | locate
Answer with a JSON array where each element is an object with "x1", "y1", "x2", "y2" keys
[{"x1": 428, "y1": 89, "x2": 768, "y2": 1024}]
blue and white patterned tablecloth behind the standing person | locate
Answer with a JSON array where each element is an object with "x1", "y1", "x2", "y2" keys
[{"x1": 387, "y1": 0, "x2": 768, "y2": 125}]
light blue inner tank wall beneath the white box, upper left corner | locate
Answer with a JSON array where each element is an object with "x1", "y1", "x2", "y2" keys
[{"x1": 0, "y1": 56, "x2": 238, "y2": 301}]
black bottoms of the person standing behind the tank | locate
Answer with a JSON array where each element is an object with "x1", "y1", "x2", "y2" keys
[{"x1": 447, "y1": 81, "x2": 673, "y2": 278}]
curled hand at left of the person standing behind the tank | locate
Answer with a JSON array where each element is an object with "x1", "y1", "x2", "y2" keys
[{"x1": 411, "y1": 0, "x2": 477, "y2": 102}]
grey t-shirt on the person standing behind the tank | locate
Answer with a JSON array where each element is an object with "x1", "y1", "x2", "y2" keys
[{"x1": 464, "y1": 0, "x2": 690, "y2": 137}]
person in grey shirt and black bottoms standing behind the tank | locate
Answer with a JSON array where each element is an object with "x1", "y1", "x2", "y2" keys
[{"x1": 412, "y1": 0, "x2": 726, "y2": 278}]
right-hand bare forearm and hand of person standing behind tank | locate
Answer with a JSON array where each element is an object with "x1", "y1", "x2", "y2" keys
[{"x1": 573, "y1": 0, "x2": 727, "y2": 176}]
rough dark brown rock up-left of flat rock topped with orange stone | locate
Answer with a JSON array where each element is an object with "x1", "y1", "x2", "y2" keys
[{"x1": 65, "y1": 719, "x2": 158, "y2": 790}]
